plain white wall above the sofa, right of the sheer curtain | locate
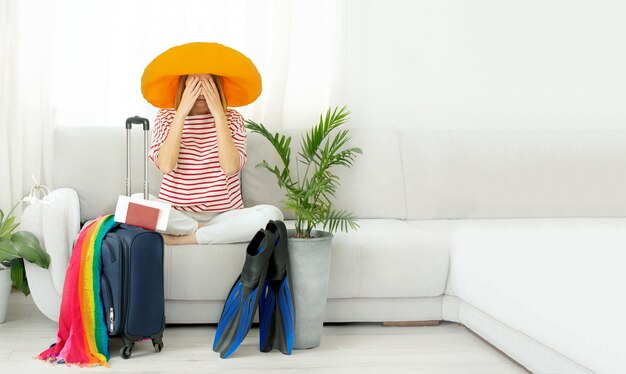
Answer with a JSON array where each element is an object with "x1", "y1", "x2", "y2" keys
[{"x1": 333, "y1": 0, "x2": 626, "y2": 128}]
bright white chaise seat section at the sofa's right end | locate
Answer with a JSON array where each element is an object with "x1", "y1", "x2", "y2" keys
[{"x1": 412, "y1": 218, "x2": 626, "y2": 373}]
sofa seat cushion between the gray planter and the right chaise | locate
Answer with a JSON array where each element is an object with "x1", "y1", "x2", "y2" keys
[{"x1": 328, "y1": 219, "x2": 448, "y2": 299}]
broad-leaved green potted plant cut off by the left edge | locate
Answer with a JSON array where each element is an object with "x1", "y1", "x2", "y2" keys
[{"x1": 0, "y1": 201, "x2": 50, "y2": 323}]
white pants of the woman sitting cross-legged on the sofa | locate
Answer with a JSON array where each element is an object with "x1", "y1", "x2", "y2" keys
[{"x1": 133, "y1": 193, "x2": 283, "y2": 244}]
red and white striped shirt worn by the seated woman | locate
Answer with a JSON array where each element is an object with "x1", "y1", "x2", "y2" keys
[{"x1": 148, "y1": 109, "x2": 247, "y2": 212}]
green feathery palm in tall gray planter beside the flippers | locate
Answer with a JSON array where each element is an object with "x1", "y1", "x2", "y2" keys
[{"x1": 246, "y1": 107, "x2": 362, "y2": 349}]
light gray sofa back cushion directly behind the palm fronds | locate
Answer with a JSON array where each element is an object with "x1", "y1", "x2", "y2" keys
[{"x1": 242, "y1": 127, "x2": 406, "y2": 219}]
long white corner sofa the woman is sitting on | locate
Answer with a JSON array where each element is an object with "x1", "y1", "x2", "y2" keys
[{"x1": 27, "y1": 127, "x2": 626, "y2": 373}]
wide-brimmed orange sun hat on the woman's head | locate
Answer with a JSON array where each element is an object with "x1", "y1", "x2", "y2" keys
[{"x1": 141, "y1": 42, "x2": 261, "y2": 108}]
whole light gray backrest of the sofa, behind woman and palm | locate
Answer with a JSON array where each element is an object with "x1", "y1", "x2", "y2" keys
[{"x1": 51, "y1": 127, "x2": 626, "y2": 220}]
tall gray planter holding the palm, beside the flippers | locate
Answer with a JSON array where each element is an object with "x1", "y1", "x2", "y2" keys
[{"x1": 288, "y1": 230, "x2": 333, "y2": 349}]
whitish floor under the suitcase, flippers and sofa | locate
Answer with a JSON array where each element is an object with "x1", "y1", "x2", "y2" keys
[{"x1": 0, "y1": 292, "x2": 527, "y2": 374}]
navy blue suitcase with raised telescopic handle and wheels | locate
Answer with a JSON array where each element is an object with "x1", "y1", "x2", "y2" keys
[{"x1": 100, "y1": 117, "x2": 165, "y2": 359}]
